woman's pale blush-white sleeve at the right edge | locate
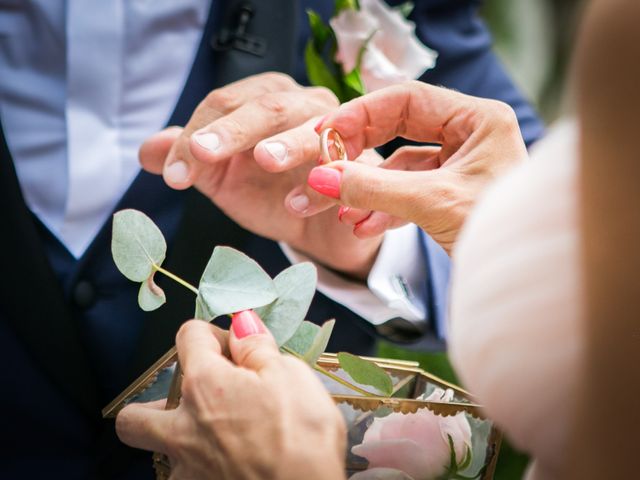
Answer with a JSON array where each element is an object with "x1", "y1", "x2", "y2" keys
[{"x1": 450, "y1": 122, "x2": 583, "y2": 480}]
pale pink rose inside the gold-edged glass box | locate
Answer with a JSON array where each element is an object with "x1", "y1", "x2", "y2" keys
[{"x1": 351, "y1": 389, "x2": 471, "y2": 480}]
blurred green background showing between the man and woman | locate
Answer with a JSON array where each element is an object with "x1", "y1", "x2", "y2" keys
[{"x1": 379, "y1": 0, "x2": 586, "y2": 480}]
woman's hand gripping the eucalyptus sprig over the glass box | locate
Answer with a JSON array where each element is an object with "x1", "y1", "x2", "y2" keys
[{"x1": 116, "y1": 311, "x2": 346, "y2": 480}]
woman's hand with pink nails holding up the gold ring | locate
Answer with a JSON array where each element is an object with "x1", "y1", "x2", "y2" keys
[{"x1": 308, "y1": 82, "x2": 527, "y2": 252}]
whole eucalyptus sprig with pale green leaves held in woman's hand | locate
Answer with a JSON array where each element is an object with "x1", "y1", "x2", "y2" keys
[{"x1": 111, "y1": 209, "x2": 393, "y2": 396}]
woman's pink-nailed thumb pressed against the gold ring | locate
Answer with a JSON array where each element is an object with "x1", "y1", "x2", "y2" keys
[{"x1": 307, "y1": 162, "x2": 437, "y2": 224}]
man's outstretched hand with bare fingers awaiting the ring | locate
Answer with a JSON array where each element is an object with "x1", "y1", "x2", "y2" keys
[{"x1": 140, "y1": 73, "x2": 381, "y2": 277}]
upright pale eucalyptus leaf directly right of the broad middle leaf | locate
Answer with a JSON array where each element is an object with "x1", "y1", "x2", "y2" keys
[{"x1": 256, "y1": 262, "x2": 318, "y2": 346}]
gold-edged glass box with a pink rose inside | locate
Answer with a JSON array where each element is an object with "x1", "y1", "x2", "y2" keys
[{"x1": 102, "y1": 348, "x2": 502, "y2": 480}]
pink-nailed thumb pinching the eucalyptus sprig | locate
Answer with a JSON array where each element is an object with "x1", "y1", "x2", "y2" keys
[{"x1": 229, "y1": 310, "x2": 280, "y2": 372}]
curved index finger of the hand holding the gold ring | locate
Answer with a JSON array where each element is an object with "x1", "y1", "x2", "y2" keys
[{"x1": 319, "y1": 81, "x2": 478, "y2": 158}]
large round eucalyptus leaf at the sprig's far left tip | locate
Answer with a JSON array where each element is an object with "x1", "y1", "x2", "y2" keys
[{"x1": 111, "y1": 209, "x2": 167, "y2": 282}]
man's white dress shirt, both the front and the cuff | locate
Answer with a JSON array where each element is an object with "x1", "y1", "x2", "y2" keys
[{"x1": 0, "y1": 0, "x2": 427, "y2": 324}]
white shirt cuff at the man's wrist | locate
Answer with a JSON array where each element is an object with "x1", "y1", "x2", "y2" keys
[{"x1": 280, "y1": 225, "x2": 427, "y2": 326}]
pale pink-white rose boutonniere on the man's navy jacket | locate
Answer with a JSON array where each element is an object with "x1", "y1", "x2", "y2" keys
[{"x1": 330, "y1": 0, "x2": 438, "y2": 92}]
